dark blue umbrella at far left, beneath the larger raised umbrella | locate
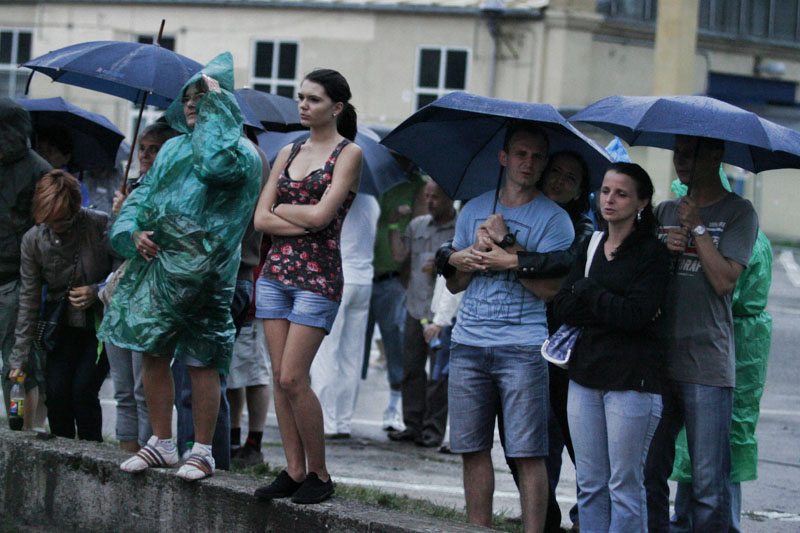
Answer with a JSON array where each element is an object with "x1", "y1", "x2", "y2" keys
[{"x1": 16, "y1": 98, "x2": 125, "y2": 170}]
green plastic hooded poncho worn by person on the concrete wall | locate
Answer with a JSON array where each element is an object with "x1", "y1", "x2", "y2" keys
[{"x1": 98, "y1": 52, "x2": 261, "y2": 373}]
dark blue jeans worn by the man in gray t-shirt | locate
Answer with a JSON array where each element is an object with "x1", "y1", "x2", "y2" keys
[{"x1": 645, "y1": 381, "x2": 733, "y2": 532}]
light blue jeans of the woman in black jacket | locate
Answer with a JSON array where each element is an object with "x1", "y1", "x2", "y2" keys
[{"x1": 567, "y1": 381, "x2": 661, "y2": 532}]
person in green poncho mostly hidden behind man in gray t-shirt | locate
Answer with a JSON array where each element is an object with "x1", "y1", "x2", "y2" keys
[{"x1": 670, "y1": 169, "x2": 772, "y2": 532}]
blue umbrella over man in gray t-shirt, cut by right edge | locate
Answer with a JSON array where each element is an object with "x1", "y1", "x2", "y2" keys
[{"x1": 570, "y1": 95, "x2": 800, "y2": 172}]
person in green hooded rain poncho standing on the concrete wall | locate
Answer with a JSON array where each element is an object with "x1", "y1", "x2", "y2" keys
[{"x1": 98, "y1": 52, "x2": 261, "y2": 481}]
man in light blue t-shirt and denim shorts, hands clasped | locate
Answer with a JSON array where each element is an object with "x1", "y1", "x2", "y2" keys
[{"x1": 447, "y1": 123, "x2": 574, "y2": 531}]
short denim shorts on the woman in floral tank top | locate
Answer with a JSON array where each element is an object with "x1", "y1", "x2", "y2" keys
[{"x1": 256, "y1": 278, "x2": 339, "y2": 333}]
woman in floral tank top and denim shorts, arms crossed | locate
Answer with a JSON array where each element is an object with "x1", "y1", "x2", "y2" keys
[{"x1": 255, "y1": 69, "x2": 361, "y2": 503}]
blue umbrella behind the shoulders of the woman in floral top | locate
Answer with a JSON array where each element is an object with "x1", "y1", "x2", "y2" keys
[{"x1": 258, "y1": 126, "x2": 408, "y2": 196}]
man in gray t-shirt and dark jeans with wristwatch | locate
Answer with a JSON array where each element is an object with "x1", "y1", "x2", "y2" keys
[{"x1": 645, "y1": 136, "x2": 758, "y2": 531}]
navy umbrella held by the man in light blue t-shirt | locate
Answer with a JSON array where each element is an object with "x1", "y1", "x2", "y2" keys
[{"x1": 381, "y1": 92, "x2": 610, "y2": 200}]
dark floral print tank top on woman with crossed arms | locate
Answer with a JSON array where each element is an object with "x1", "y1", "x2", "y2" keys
[{"x1": 261, "y1": 139, "x2": 356, "y2": 302}]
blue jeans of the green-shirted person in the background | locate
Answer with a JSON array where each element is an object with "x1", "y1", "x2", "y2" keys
[{"x1": 361, "y1": 278, "x2": 406, "y2": 387}]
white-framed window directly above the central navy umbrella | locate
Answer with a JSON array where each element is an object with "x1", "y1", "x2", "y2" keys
[{"x1": 414, "y1": 46, "x2": 469, "y2": 109}]
